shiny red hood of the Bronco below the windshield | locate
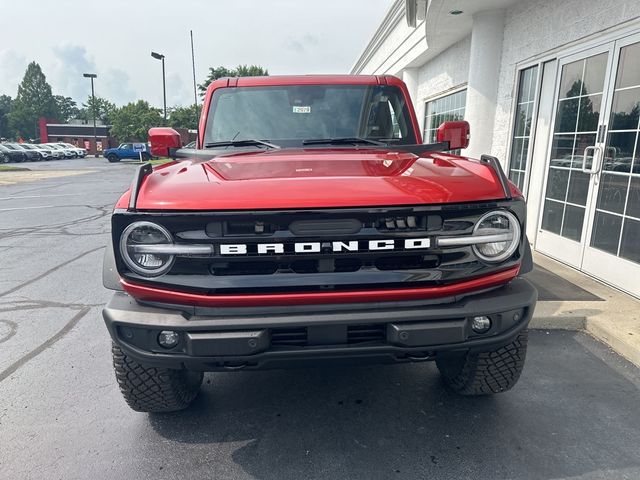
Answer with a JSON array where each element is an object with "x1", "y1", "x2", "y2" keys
[{"x1": 129, "y1": 149, "x2": 504, "y2": 210}]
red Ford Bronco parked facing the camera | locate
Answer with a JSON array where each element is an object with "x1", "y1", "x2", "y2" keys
[{"x1": 103, "y1": 76, "x2": 537, "y2": 412}]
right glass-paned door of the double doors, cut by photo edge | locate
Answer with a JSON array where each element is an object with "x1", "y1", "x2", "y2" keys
[{"x1": 581, "y1": 35, "x2": 640, "y2": 297}]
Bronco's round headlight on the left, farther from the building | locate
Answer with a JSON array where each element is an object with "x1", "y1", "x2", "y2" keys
[{"x1": 120, "y1": 222, "x2": 175, "y2": 277}]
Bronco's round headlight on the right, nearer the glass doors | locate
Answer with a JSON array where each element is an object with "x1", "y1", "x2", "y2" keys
[{"x1": 473, "y1": 211, "x2": 520, "y2": 263}]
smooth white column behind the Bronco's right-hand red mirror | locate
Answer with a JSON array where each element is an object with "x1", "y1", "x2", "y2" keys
[{"x1": 462, "y1": 10, "x2": 504, "y2": 160}]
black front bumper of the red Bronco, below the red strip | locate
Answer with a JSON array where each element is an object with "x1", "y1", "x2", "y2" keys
[{"x1": 103, "y1": 279, "x2": 537, "y2": 371}]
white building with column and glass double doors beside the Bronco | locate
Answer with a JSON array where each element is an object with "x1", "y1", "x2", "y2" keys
[{"x1": 352, "y1": 0, "x2": 640, "y2": 297}]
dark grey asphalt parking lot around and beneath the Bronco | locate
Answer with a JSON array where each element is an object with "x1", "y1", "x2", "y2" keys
[{"x1": 0, "y1": 159, "x2": 640, "y2": 480}]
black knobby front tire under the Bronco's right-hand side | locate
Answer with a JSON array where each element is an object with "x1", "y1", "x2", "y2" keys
[{"x1": 436, "y1": 330, "x2": 529, "y2": 395}]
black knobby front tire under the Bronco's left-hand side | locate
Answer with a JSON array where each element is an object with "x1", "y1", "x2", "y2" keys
[{"x1": 111, "y1": 344, "x2": 204, "y2": 413}]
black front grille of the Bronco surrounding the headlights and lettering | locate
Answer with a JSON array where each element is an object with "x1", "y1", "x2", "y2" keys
[{"x1": 113, "y1": 201, "x2": 524, "y2": 294}]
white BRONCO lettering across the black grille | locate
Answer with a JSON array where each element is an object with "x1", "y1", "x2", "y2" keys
[{"x1": 219, "y1": 238, "x2": 431, "y2": 255}]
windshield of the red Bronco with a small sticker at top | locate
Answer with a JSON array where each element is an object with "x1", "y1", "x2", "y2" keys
[{"x1": 205, "y1": 85, "x2": 416, "y2": 146}]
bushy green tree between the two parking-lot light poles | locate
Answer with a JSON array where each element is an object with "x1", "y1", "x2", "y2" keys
[{"x1": 110, "y1": 100, "x2": 163, "y2": 142}]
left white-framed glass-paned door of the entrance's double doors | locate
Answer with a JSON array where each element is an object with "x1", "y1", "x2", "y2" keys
[{"x1": 536, "y1": 44, "x2": 613, "y2": 268}]
